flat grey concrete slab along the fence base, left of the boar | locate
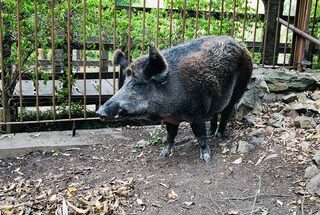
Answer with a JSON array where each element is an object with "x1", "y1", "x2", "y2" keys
[{"x1": 0, "y1": 128, "x2": 127, "y2": 159}]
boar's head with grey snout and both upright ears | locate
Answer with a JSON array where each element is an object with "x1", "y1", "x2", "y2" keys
[{"x1": 97, "y1": 47, "x2": 168, "y2": 121}]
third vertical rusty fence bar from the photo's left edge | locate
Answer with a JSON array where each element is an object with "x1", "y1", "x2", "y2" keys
[{"x1": 34, "y1": 0, "x2": 40, "y2": 121}]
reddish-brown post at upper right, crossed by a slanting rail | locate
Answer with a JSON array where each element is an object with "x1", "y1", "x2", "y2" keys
[{"x1": 294, "y1": 0, "x2": 312, "y2": 72}]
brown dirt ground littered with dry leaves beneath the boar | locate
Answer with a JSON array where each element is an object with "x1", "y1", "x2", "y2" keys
[{"x1": 0, "y1": 123, "x2": 320, "y2": 215}]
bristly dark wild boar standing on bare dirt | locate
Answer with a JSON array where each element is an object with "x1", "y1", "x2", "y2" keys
[{"x1": 97, "y1": 36, "x2": 253, "y2": 162}]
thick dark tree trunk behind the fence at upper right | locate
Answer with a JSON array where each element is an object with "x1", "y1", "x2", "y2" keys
[{"x1": 261, "y1": 0, "x2": 284, "y2": 65}]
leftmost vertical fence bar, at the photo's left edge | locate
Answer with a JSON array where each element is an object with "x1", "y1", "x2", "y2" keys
[{"x1": 0, "y1": 0, "x2": 7, "y2": 123}]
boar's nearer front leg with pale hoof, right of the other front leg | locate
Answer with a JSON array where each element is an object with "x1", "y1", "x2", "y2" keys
[{"x1": 191, "y1": 122, "x2": 211, "y2": 163}]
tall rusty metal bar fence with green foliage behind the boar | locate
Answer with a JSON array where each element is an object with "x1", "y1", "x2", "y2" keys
[{"x1": 0, "y1": 0, "x2": 320, "y2": 131}]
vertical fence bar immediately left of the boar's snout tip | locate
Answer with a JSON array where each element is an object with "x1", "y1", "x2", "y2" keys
[{"x1": 83, "y1": 0, "x2": 87, "y2": 119}]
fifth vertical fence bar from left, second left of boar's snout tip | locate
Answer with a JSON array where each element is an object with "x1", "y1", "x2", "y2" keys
[{"x1": 67, "y1": 0, "x2": 72, "y2": 119}]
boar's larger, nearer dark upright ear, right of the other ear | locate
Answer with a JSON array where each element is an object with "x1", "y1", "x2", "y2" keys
[{"x1": 143, "y1": 46, "x2": 168, "y2": 80}]
